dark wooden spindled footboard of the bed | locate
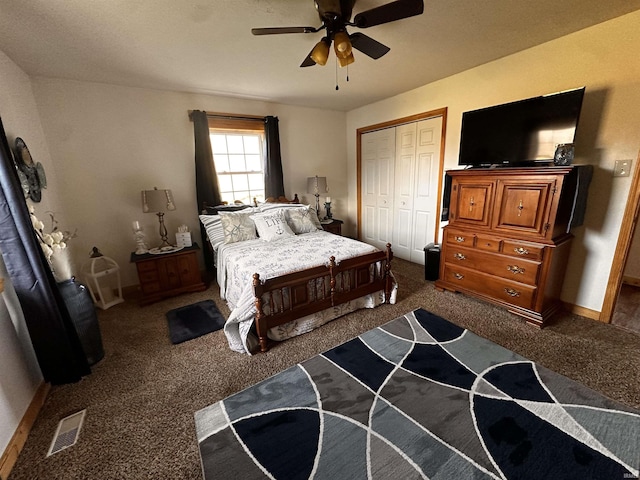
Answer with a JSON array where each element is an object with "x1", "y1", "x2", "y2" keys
[{"x1": 253, "y1": 243, "x2": 393, "y2": 352}]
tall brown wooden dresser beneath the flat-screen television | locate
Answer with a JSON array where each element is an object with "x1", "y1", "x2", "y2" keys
[{"x1": 435, "y1": 166, "x2": 577, "y2": 326}]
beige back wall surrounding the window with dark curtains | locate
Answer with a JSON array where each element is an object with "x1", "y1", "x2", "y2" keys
[{"x1": 32, "y1": 77, "x2": 347, "y2": 285}]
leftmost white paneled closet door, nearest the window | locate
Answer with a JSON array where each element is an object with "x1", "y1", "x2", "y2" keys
[{"x1": 361, "y1": 129, "x2": 395, "y2": 249}]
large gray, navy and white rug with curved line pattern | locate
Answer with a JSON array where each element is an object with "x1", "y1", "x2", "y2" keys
[{"x1": 195, "y1": 309, "x2": 640, "y2": 480}]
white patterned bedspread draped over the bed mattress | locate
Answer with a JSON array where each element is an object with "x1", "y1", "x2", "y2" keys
[{"x1": 217, "y1": 231, "x2": 396, "y2": 353}]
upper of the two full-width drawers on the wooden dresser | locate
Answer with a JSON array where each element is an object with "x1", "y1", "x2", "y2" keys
[{"x1": 444, "y1": 245, "x2": 540, "y2": 285}]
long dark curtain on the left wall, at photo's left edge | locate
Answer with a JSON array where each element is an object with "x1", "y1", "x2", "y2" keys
[{"x1": 0, "y1": 119, "x2": 91, "y2": 385}]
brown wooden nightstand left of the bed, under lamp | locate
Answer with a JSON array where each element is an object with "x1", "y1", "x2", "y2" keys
[{"x1": 131, "y1": 243, "x2": 207, "y2": 305}]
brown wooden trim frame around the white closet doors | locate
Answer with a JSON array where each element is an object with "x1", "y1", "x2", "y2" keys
[{"x1": 356, "y1": 107, "x2": 447, "y2": 243}]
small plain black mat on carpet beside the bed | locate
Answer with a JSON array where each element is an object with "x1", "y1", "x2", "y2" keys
[{"x1": 167, "y1": 300, "x2": 225, "y2": 344}]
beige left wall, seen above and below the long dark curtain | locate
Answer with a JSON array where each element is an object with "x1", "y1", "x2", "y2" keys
[{"x1": 0, "y1": 52, "x2": 44, "y2": 456}]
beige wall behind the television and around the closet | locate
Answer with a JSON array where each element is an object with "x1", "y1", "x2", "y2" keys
[{"x1": 347, "y1": 12, "x2": 640, "y2": 311}]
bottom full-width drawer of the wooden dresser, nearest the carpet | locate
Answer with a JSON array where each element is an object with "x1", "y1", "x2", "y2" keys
[{"x1": 444, "y1": 265, "x2": 536, "y2": 308}]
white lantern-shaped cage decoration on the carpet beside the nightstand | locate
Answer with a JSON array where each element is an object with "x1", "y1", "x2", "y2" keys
[{"x1": 82, "y1": 247, "x2": 124, "y2": 310}]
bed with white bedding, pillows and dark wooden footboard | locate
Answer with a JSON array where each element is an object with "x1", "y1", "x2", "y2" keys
[{"x1": 200, "y1": 203, "x2": 397, "y2": 354}]
